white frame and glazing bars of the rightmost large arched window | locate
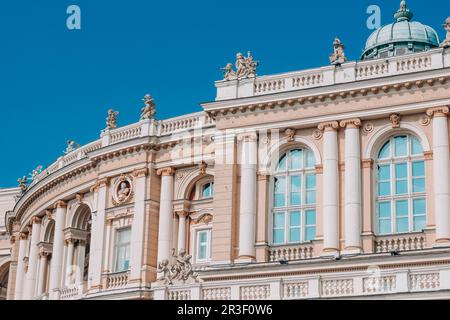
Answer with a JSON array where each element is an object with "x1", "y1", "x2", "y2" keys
[{"x1": 374, "y1": 133, "x2": 428, "y2": 236}]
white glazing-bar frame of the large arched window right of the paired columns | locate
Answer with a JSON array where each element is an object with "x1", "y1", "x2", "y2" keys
[{"x1": 373, "y1": 133, "x2": 428, "y2": 237}]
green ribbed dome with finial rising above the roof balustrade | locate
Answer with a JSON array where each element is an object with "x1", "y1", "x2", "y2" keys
[{"x1": 362, "y1": 1, "x2": 439, "y2": 60}]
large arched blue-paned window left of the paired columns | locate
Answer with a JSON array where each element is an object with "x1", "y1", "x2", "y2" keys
[{"x1": 272, "y1": 149, "x2": 316, "y2": 245}]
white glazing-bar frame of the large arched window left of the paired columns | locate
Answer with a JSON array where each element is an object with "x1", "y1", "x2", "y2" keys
[{"x1": 269, "y1": 146, "x2": 317, "y2": 246}]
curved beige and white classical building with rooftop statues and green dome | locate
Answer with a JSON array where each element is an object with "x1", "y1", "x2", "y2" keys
[{"x1": 0, "y1": 1, "x2": 450, "y2": 300}]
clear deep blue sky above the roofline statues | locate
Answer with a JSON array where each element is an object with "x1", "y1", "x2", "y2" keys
[{"x1": 0, "y1": 0, "x2": 450, "y2": 187}]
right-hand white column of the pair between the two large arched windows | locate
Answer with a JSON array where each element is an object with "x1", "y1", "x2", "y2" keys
[{"x1": 341, "y1": 119, "x2": 362, "y2": 253}]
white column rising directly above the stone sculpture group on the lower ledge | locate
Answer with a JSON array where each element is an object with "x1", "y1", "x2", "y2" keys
[{"x1": 157, "y1": 168, "x2": 174, "y2": 262}]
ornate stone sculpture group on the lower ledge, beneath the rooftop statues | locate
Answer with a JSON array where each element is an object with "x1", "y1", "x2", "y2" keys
[{"x1": 157, "y1": 249, "x2": 200, "y2": 285}]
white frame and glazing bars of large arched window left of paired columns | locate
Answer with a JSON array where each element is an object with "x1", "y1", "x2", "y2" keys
[{"x1": 269, "y1": 146, "x2": 317, "y2": 246}]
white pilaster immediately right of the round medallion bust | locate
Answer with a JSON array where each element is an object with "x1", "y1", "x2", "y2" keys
[{"x1": 129, "y1": 168, "x2": 148, "y2": 282}]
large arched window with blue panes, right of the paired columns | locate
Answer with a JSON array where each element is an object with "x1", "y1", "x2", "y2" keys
[{"x1": 376, "y1": 135, "x2": 426, "y2": 235}]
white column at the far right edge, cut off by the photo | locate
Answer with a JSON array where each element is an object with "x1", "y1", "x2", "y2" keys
[{"x1": 427, "y1": 107, "x2": 450, "y2": 244}]
